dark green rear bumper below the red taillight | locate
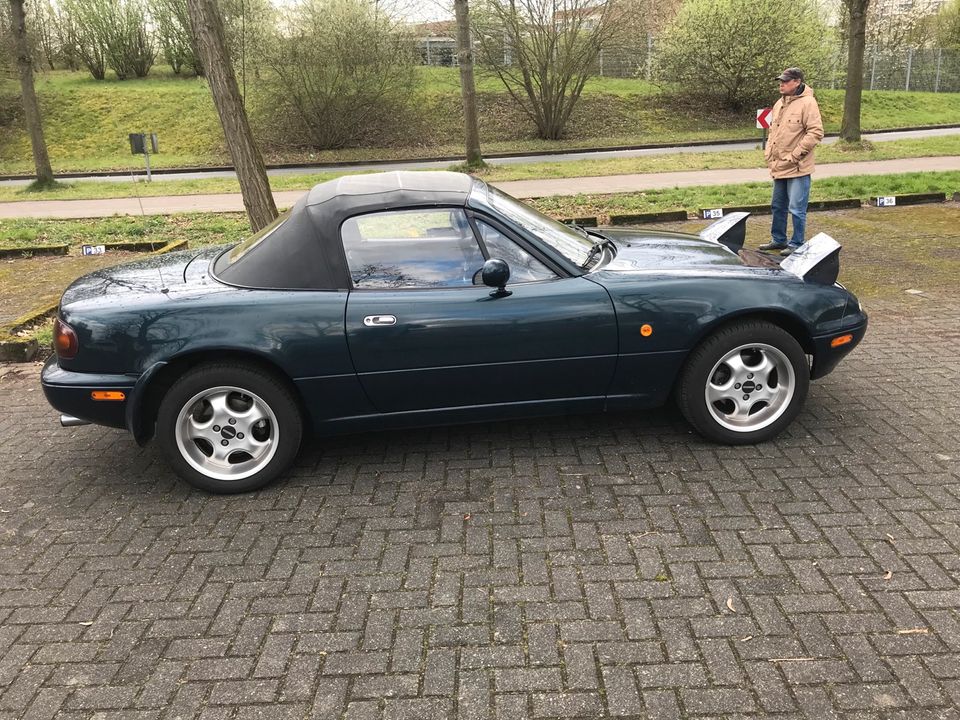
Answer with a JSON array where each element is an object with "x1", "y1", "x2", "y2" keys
[{"x1": 40, "y1": 357, "x2": 137, "y2": 429}]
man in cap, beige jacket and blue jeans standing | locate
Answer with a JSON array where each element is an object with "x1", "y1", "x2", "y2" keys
[{"x1": 760, "y1": 68, "x2": 823, "y2": 256}]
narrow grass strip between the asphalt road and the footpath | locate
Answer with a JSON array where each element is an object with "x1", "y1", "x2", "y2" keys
[{"x1": 0, "y1": 135, "x2": 960, "y2": 202}]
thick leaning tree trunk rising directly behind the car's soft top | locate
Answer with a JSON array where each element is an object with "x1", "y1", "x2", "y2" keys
[{"x1": 187, "y1": 0, "x2": 277, "y2": 232}]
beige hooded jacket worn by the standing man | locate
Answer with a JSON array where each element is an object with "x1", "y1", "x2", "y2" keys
[{"x1": 763, "y1": 85, "x2": 823, "y2": 180}]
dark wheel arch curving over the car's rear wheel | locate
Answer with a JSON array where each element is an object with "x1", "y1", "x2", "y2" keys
[{"x1": 127, "y1": 350, "x2": 310, "y2": 445}]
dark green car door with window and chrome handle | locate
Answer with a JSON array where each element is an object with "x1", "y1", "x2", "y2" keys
[{"x1": 341, "y1": 208, "x2": 617, "y2": 413}]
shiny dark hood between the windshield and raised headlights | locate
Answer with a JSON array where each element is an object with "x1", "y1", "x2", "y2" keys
[{"x1": 599, "y1": 228, "x2": 778, "y2": 272}]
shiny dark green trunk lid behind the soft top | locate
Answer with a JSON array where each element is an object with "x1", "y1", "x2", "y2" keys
[{"x1": 60, "y1": 248, "x2": 222, "y2": 307}]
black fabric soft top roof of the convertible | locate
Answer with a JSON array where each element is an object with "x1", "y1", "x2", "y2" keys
[{"x1": 214, "y1": 171, "x2": 479, "y2": 290}]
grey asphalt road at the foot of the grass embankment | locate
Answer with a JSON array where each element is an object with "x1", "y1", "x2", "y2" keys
[{"x1": 0, "y1": 126, "x2": 960, "y2": 185}]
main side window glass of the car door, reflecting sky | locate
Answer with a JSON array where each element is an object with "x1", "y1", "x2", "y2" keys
[{"x1": 340, "y1": 208, "x2": 483, "y2": 288}]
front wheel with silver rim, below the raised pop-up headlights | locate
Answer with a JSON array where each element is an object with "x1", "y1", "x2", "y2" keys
[{"x1": 677, "y1": 320, "x2": 810, "y2": 445}]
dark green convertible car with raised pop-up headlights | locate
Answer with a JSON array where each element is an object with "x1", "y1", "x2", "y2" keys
[{"x1": 42, "y1": 172, "x2": 867, "y2": 492}]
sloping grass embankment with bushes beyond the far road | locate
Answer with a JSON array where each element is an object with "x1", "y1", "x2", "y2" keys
[{"x1": 0, "y1": 66, "x2": 960, "y2": 174}]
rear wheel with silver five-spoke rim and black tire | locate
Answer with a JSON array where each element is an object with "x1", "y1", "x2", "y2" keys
[{"x1": 157, "y1": 363, "x2": 303, "y2": 494}]
